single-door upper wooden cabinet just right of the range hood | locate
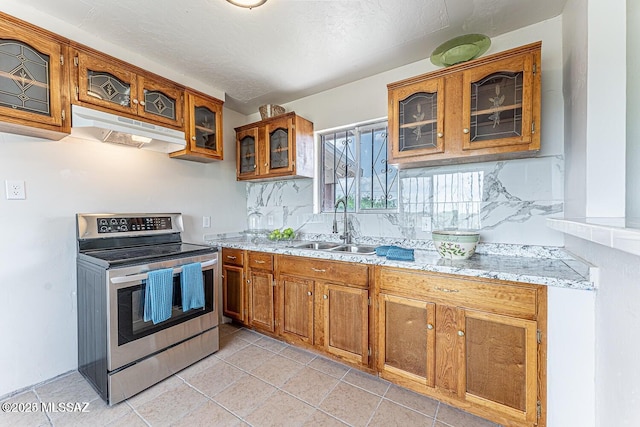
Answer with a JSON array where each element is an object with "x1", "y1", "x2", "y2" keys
[{"x1": 170, "y1": 90, "x2": 223, "y2": 163}]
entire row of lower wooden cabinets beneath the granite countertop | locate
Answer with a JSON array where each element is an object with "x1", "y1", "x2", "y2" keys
[{"x1": 223, "y1": 249, "x2": 547, "y2": 427}]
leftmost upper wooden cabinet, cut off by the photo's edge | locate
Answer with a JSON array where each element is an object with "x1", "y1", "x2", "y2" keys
[{"x1": 0, "y1": 13, "x2": 71, "y2": 140}]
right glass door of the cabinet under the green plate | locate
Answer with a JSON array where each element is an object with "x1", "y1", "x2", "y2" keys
[{"x1": 462, "y1": 54, "x2": 539, "y2": 150}]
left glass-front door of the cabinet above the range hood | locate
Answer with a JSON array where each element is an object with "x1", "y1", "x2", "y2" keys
[{"x1": 75, "y1": 51, "x2": 138, "y2": 114}]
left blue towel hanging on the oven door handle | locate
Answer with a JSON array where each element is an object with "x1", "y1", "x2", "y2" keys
[{"x1": 144, "y1": 268, "x2": 173, "y2": 325}]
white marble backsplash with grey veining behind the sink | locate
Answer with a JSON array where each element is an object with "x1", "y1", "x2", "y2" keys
[{"x1": 247, "y1": 156, "x2": 564, "y2": 246}]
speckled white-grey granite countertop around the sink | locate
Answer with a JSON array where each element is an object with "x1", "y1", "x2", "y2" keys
[{"x1": 205, "y1": 234, "x2": 595, "y2": 290}]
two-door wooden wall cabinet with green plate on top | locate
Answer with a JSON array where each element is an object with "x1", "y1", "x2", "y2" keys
[{"x1": 388, "y1": 42, "x2": 541, "y2": 167}]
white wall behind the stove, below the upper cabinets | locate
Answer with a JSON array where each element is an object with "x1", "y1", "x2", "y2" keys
[{"x1": 0, "y1": 109, "x2": 245, "y2": 396}]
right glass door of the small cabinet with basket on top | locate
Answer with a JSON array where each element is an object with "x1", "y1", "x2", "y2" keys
[{"x1": 265, "y1": 117, "x2": 294, "y2": 174}]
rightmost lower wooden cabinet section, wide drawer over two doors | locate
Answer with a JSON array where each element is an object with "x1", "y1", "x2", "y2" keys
[{"x1": 376, "y1": 268, "x2": 546, "y2": 426}]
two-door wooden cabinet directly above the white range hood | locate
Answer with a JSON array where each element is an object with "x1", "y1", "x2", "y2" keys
[{"x1": 72, "y1": 48, "x2": 184, "y2": 130}]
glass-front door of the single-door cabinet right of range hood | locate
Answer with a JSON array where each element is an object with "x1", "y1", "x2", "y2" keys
[{"x1": 187, "y1": 93, "x2": 222, "y2": 160}]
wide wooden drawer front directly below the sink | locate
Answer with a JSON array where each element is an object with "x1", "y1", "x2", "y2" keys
[{"x1": 278, "y1": 256, "x2": 369, "y2": 287}]
